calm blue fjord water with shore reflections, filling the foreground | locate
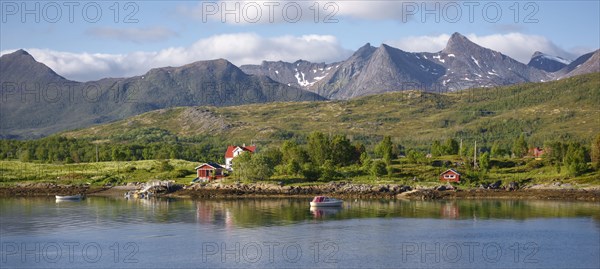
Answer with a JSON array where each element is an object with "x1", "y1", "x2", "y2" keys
[{"x1": 0, "y1": 197, "x2": 600, "y2": 268}]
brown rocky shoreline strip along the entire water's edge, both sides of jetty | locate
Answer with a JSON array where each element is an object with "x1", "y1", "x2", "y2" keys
[{"x1": 0, "y1": 182, "x2": 600, "y2": 201}]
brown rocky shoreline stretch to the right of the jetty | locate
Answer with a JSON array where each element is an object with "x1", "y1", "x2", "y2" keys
[{"x1": 167, "y1": 182, "x2": 600, "y2": 201}]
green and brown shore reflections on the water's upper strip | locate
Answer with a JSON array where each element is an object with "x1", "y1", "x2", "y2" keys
[{"x1": 0, "y1": 197, "x2": 600, "y2": 234}]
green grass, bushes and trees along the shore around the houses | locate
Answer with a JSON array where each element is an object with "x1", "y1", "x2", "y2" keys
[{"x1": 0, "y1": 132, "x2": 600, "y2": 201}]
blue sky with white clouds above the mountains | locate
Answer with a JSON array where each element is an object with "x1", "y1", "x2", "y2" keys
[{"x1": 0, "y1": 0, "x2": 600, "y2": 80}]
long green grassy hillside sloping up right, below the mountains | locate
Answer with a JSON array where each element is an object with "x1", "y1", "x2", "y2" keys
[{"x1": 63, "y1": 73, "x2": 600, "y2": 147}]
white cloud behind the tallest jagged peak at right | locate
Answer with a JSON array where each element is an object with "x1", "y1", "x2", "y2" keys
[{"x1": 388, "y1": 33, "x2": 580, "y2": 63}]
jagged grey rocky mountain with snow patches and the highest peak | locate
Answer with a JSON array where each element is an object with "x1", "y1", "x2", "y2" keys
[{"x1": 244, "y1": 33, "x2": 552, "y2": 100}]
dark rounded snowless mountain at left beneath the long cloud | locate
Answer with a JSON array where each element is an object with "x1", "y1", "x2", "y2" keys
[{"x1": 0, "y1": 50, "x2": 324, "y2": 138}]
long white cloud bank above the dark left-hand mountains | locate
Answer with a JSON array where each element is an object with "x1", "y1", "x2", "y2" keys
[{"x1": 0, "y1": 33, "x2": 351, "y2": 81}]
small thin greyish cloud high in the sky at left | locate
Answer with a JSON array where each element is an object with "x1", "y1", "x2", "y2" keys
[{"x1": 86, "y1": 26, "x2": 177, "y2": 43}]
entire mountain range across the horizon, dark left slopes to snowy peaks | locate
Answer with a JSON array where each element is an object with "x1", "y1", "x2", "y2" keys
[{"x1": 0, "y1": 33, "x2": 600, "y2": 139}]
